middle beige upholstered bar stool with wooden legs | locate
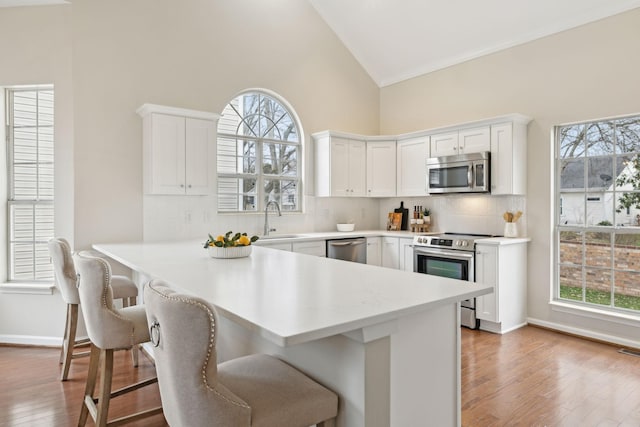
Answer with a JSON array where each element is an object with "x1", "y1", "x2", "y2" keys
[{"x1": 75, "y1": 252, "x2": 162, "y2": 426}]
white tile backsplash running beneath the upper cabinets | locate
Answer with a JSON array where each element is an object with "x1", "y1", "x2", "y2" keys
[{"x1": 143, "y1": 195, "x2": 527, "y2": 241}]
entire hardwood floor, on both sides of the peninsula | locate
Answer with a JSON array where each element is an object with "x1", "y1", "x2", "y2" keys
[{"x1": 0, "y1": 327, "x2": 640, "y2": 427}]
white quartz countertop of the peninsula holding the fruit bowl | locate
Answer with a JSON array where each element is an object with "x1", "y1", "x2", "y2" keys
[{"x1": 93, "y1": 241, "x2": 493, "y2": 346}]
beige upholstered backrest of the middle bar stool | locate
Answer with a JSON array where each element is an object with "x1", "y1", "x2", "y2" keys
[{"x1": 74, "y1": 252, "x2": 135, "y2": 349}]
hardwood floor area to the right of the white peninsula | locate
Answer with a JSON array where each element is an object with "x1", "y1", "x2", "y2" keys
[{"x1": 462, "y1": 327, "x2": 640, "y2": 427}]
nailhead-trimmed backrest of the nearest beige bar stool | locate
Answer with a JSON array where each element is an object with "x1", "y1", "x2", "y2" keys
[{"x1": 144, "y1": 279, "x2": 251, "y2": 426}]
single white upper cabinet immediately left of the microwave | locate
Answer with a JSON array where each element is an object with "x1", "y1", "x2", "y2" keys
[{"x1": 396, "y1": 136, "x2": 429, "y2": 197}]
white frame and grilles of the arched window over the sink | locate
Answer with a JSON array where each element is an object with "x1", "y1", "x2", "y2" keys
[{"x1": 216, "y1": 89, "x2": 305, "y2": 214}]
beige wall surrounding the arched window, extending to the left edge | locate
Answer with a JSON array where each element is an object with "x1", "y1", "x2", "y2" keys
[{"x1": 0, "y1": 0, "x2": 379, "y2": 344}]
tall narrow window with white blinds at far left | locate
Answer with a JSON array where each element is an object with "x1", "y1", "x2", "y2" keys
[{"x1": 5, "y1": 87, "x2": 54, "y2": 282}]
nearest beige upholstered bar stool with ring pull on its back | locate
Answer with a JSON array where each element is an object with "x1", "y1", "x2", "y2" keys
[{"x1": 144, "y1": 279, "x2": 338, "y2": 427}]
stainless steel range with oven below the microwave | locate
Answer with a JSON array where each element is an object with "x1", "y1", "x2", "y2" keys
[{"x1": 413, "y1": 233, "x2": 493, "y2": 329}]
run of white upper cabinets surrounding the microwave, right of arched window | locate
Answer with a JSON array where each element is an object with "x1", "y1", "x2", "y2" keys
[{"x1": 312, "y1": 114, "x2": 531, "y2": 197}]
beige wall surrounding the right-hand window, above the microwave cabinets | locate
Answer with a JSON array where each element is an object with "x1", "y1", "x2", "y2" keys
[{"x1": 380, "y1": 9, "x2": 640, "y2": 342}]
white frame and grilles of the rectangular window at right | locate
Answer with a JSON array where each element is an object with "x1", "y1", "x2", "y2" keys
[{"x1": 551, "y1": 114, "x2": 640, "y2": 318}]
